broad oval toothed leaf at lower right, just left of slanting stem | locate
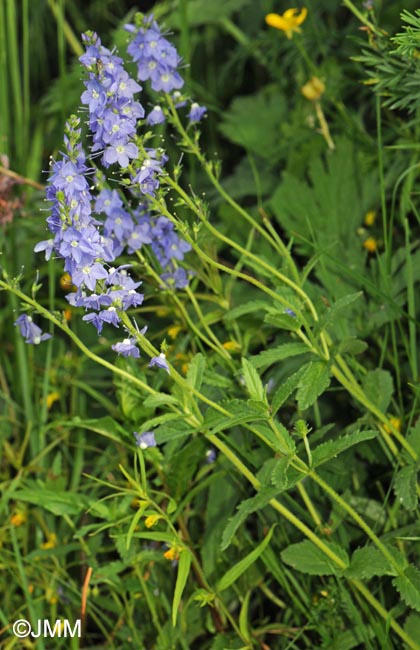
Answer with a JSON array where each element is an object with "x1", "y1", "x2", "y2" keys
[{"x1": 281, "y1": 540, "x2": 349, "y2": 576}]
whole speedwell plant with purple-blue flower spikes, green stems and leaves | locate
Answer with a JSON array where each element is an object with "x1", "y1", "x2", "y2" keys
[{"x1": 1, "y1": 10, "x2": 420, "y2": 648}]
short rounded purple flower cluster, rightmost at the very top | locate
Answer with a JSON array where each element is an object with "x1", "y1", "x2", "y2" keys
[{"x1": 125, "y1": 16, "x2": 184, "y2": 93}]
